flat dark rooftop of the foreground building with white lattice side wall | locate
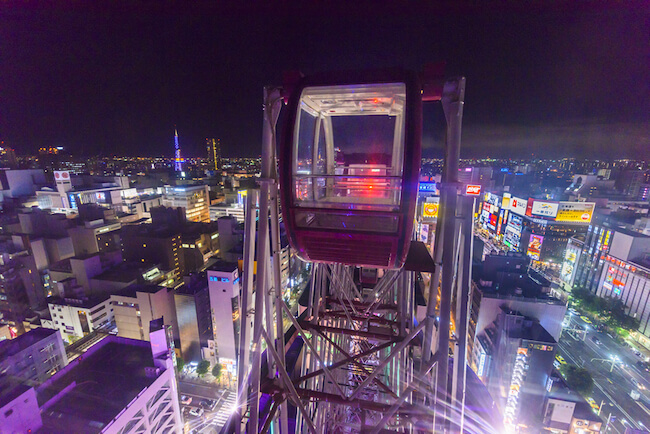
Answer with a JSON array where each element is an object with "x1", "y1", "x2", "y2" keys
[{"x1": 37, "y1": 336, "x2": 155, "y2": 433}]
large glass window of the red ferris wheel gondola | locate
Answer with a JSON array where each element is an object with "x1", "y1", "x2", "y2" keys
[{"x1": 293, "y1": 83, "x2": 406, "y2": 214}]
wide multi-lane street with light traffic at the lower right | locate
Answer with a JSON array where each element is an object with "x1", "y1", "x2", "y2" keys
[{"x1": 558, "y1": 312, "x2": 650, "y2": 433}]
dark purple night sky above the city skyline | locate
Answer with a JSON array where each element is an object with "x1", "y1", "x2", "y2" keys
[{"x1": 0, "y1": 1, "x2": 650, "y2": 158}]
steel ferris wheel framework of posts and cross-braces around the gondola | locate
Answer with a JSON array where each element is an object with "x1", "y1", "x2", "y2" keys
[{"x1": 235, "y1": 78, "x2": 472, "y2": 434}]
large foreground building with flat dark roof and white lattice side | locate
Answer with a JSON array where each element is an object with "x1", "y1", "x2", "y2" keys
[{"x1": 6, "y1": 327, "x2": 183, "y2": 434}]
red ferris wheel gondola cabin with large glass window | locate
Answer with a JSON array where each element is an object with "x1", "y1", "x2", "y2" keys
[{"x1": 278, "y1": 70, "x2": 422, "y2": 268}]
